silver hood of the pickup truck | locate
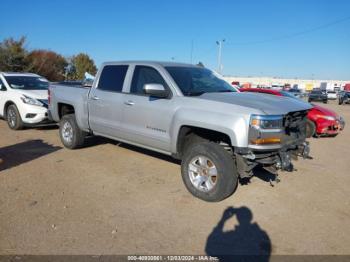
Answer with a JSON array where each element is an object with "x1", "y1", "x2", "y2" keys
[{"x1": 198, "y1": 92, "x2": 312, "y2": 115}]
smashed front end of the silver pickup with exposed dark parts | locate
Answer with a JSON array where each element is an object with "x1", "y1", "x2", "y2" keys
[{"x1": 234, "y1": 111, "x2": 310, "y2": 178}]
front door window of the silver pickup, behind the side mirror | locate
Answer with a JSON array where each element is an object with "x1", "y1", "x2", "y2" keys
[{"x1": 130, "y1": 66, "x2": 167, "y2": 95}]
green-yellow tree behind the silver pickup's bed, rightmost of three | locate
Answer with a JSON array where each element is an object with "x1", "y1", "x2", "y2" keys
[{"x1": 70, "y1": 53, "x2": 97, "y2": 80}]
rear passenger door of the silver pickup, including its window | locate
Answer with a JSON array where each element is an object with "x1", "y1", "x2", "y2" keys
[{"x1": 88, "y1": 65, "x2": 128, "y2": 138}]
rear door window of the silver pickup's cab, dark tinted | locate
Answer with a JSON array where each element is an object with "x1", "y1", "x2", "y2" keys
[{"x1": 97, "y1": 65, "x2": 128, "y2": 92}]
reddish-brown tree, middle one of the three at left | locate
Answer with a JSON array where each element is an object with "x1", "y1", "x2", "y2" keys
[{"x1": 26, "y1": 49, "x2": 68, "y2": 81}]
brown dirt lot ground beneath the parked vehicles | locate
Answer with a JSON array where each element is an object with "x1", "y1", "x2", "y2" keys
[{"x1": 0, "y1": 102, "x2": 350, "y2": 254}]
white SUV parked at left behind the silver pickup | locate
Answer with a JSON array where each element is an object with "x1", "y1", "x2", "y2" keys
[{"x1": 0, "y1": 72, "x2": 49, "y2": 130}]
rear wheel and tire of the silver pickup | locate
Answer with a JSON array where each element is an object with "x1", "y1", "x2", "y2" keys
[{"x1": 59, "y1": 114, "x2": 86, "y2": 149}]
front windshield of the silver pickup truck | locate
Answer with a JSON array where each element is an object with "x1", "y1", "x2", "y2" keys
[{"x1": 165, "y1": 66, "x2": 237, "y2": 96}]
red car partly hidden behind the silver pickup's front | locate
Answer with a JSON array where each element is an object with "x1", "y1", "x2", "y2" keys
[{"x1": 240, "y1": 88, "x2": 345, "y2": 137}]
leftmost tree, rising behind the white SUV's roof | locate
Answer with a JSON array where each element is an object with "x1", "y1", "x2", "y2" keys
[{"x1": 0, "y1": 36, "x2": 28, "y2": 72}]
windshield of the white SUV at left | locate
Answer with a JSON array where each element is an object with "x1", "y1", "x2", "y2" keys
[{"x1": 5, "y1": 76, "x2": 49, "y2": 90}]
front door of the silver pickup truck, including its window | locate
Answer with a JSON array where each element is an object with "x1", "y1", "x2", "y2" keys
[{"x1": 122, "y1": 65, "x2": 175, "y2": 152}]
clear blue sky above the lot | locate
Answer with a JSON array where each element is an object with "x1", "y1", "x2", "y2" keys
[{"x1": 0, "y1": 0, "x2": 350, "y2": 80}]
